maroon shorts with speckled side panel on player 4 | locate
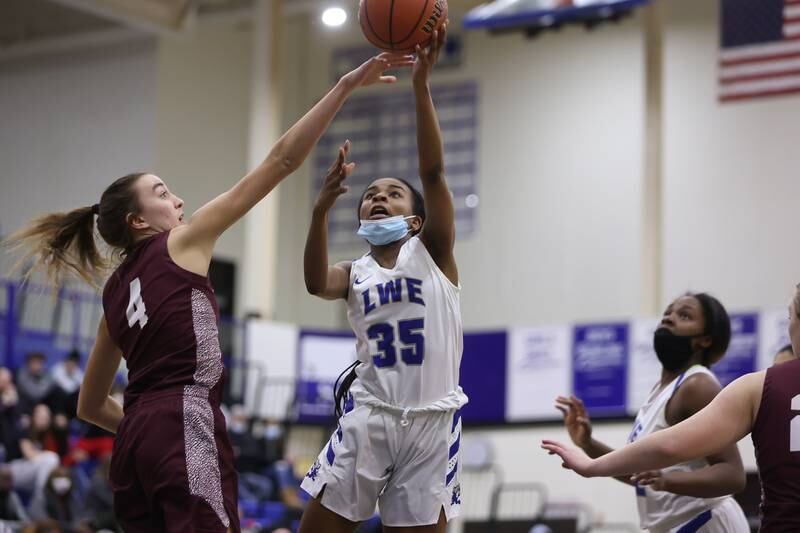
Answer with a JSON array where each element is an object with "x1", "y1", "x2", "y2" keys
[{"x1": 110, "y1": 386, "x2": 240, "y2": 533}]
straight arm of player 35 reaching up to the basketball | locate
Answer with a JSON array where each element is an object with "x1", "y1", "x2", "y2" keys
[{"x1": 412, "y1": 25, "x2": 458, "y2": 284}]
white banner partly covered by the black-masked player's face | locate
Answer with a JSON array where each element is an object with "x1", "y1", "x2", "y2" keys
[{"x1": 627, "y1": 318, "x2": 661, "y2": 416}]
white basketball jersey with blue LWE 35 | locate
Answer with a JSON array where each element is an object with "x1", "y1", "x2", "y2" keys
[{"x1": 347, "y1": 237, "x2": 467, "y2": 410}]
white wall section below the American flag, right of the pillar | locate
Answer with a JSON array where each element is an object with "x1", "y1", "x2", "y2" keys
[{"x1": 663, "y1": 0, "x2": 800, "y2": 309}]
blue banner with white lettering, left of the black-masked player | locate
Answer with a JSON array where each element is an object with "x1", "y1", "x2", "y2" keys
[{"x1": 572, "y1": 322, "x2": 629, "y2": 416}]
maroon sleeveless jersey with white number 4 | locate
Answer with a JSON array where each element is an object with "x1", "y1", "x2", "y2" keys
[{"x1": 103, "y1": 231, "x2": 223, "y2": 407}]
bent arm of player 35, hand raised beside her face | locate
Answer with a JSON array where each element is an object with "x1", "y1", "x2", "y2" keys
[{"x1": 303, "y1": 141, "x2": 355, "y2": 300}]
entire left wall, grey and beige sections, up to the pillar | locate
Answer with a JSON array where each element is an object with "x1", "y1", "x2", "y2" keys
[{"x1": 0, "y1": 20, "x2": 253, "y2": 316}]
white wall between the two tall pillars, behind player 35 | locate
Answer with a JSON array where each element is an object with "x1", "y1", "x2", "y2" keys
[{"x1": 276, "y1": 5, "x2": 644, "y2": 328}]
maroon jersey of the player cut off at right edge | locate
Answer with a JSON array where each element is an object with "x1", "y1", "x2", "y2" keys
[{"x1": 752, "y1": 361, "x2": 800, "y2": 533}]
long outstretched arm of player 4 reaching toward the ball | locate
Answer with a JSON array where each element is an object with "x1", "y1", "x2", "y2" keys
[{"x1": 171, "y1": 53, "x2": 413, "y2": 261}]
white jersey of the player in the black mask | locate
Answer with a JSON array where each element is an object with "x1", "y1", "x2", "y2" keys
[{"x1": 628, "y1": 365, "x2": 726, "y2": 531}]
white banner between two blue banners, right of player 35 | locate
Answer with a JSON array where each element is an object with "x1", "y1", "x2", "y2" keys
[{"x1": 506, "y1": 326, "x2": 572, "y2": 422}]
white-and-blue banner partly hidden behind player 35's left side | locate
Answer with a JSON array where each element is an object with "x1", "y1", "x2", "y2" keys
[{"x1": 295, "y1": 331, "x2": 356, "y2": 423}]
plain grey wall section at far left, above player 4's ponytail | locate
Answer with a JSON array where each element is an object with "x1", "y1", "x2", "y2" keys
[{"x1": 0, "y1": 41, "x2": 156, "y2": 244}]
